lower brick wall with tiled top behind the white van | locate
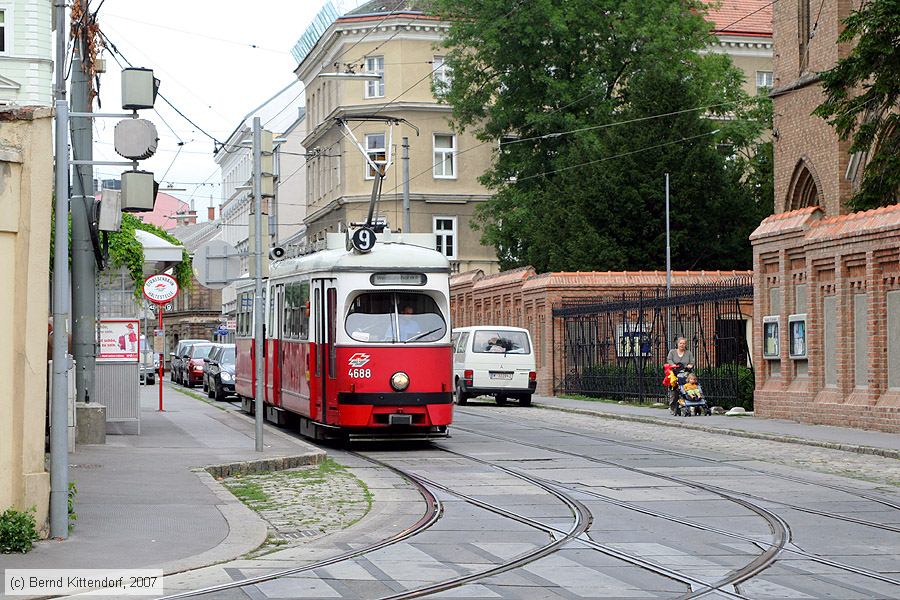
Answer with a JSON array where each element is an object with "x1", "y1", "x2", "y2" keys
[{"x1": 450, "y1": 267, "x2": 750, "y2": 395}]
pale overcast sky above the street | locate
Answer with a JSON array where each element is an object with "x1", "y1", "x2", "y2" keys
[{"x1": 81, "y1": 0, "x2": 362, "y2": 220}]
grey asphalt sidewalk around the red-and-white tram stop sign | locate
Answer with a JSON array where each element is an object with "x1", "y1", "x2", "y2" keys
[{"x1": 0, "y1": 382, "x2": 325, "y2": 573}]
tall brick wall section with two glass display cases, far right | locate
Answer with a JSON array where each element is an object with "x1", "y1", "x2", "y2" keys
[{"x1": 751, "y1": 205, "x2": 900, "y2": 432}]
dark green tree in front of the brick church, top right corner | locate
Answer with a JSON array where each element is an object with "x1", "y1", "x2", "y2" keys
[{"x1": 814, "y1": 0, "x2": 900, "y2": 210}]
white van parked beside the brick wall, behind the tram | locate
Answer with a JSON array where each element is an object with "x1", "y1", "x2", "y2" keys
[{"x1": 451, "y1": 325, "x2": 537, "y2": 406}]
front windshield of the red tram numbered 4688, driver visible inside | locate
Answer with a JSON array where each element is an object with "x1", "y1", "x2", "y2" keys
[{"x1": 346, "y1": 292, "x2": 447, "y2": 343}]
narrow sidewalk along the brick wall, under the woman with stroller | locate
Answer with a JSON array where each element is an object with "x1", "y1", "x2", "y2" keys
[{"x1": 533, "y1": 396, "x2": 900, "y2": 459}]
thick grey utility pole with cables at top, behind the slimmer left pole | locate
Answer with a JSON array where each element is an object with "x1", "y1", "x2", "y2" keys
[{"x1": 70, "y1": 0, "x2": 97, "y2": 402}]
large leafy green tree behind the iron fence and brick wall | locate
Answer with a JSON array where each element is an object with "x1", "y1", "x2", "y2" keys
[{"x1": 433, "y1": 0, "x2": 772, "y2": 271}]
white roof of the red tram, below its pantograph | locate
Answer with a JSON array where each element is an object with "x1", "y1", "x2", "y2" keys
[{"x1": 269, "y1": 234, "x2": 450, "y2": 278}]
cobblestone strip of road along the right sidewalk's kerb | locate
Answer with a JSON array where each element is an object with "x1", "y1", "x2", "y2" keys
[{"x1": 456, "y1": 403, "x2": 900, "y2": 486}]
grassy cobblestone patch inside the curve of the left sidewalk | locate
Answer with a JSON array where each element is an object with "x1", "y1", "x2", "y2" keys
[{"x1": 222, "y1": 460, "x2": 372, "y2": 551}]
